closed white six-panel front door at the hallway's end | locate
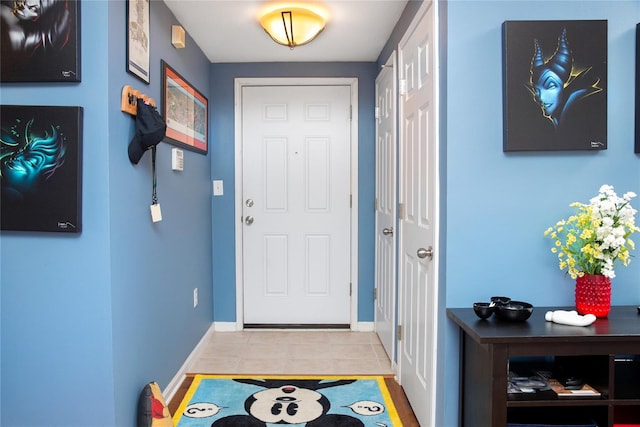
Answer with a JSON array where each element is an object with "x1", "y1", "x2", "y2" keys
[{"x1": 242, "y1": 86, "x2": 351, "y2": 325}]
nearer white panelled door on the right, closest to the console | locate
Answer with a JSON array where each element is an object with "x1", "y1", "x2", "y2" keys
[{"x1": 398, "y1": 1, "x2": 438, "y2": 426}]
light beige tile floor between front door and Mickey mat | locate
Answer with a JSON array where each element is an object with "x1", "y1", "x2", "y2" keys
[{"x1": 188, "y1": 330, "x2": 393, "y2": 375}]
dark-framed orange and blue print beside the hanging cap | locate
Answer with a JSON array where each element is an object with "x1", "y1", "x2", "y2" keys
[{"x1": 162, "y1": 61, "x2": 209, "y2": 154}]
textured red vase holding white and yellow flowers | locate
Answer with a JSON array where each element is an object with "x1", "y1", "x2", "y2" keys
[{"x1": 576, "y1": 274, "x2": 611, "y2": 317}]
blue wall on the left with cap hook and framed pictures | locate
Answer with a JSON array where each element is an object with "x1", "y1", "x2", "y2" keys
[{"x1": 0, "y1": 0, "x2": 213, "y2": 427}]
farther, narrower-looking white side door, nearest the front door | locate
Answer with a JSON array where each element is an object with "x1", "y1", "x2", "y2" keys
[{"x1": 375, "y1": 51, "x2": 397, "y2": 360}]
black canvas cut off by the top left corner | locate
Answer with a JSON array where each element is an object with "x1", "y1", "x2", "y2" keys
[{"x1": 0, "y1": 0, "x2": 80, "y2": 82}]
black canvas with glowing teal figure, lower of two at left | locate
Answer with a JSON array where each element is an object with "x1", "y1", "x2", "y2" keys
[{"x1": 0, "y1": 105, "x2": 83, "y2": 233}]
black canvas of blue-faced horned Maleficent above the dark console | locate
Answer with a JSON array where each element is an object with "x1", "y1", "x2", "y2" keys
[{"x1": 502, "y1": 20, "x2": 607, "y2": 151}]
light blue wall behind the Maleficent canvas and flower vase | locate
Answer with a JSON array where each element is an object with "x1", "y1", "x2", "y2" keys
[{"x1": 439, "y1": 0, "x2": 640, "y2": 426}]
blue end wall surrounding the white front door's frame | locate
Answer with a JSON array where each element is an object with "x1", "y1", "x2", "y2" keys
[{"x1": 211, "y1": 62, "x2": 377, "y2": 322}]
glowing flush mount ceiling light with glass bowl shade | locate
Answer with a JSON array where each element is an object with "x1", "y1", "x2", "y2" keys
[{"x1": 260, "y1": 7, "x2": 325, "y2": 49}]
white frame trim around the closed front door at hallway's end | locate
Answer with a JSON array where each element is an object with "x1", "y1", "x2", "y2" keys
[{"x1": 234, "y1": 77, "x2": 358, "y2": 330}]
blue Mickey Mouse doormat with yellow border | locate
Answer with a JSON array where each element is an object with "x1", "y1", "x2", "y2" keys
[{"x1": 173, "y1": 375, "x2": 402, "y2": 427}]
